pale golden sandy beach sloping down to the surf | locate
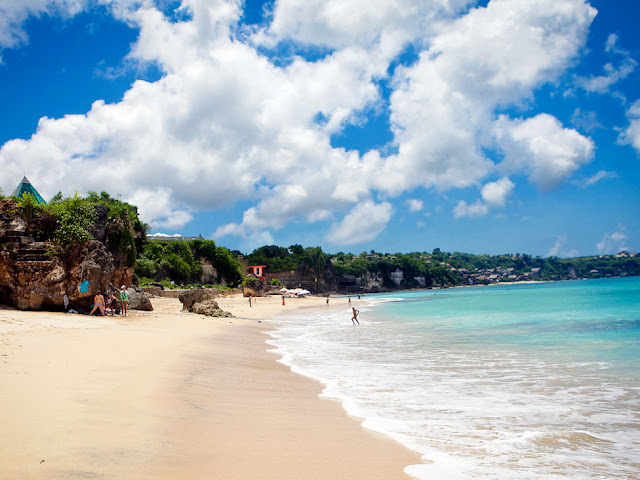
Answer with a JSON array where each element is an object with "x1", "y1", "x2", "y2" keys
[{"x1": 0, "y1": 296, "x2": 420, "y2": 480}]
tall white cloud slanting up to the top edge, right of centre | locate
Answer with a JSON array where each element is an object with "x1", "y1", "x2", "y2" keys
[{"x1": 377, "y1": 0, "x2": 595, "y2": 194}]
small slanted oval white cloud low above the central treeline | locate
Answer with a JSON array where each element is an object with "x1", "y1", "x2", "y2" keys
[{"x1": 327, "y1": 200, "x2": 392, "y2": 245}]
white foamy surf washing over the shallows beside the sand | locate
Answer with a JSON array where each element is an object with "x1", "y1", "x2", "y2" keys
[{"x1": 268, "y1": 282, "x2": 640, "y2": 480}]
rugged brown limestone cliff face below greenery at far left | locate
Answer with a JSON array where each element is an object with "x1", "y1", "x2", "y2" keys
[{"x1": 0, "y1": 199, "x2": 134, "y2": 311}]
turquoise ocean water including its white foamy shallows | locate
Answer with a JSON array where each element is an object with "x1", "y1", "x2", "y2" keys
[{"x1": 268, "y1": 277, "x2": 640, "y2": 480}]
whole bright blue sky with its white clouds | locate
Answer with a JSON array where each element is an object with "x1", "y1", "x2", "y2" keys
[{"x1": 0, "y1": 0, "x2": 640, "y2": 257}]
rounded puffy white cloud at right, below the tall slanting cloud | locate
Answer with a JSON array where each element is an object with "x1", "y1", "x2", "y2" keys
[{"x1": 495, "y1": 114, "x2": 595, "y2": 191}]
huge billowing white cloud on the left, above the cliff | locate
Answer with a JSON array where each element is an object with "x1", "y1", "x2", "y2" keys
[{"x1": 0, "y1": 1, "x2": 377, "y2": 230}]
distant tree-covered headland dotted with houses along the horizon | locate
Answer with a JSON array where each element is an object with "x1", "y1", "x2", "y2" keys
[{"x1": 238, "y1": 245, "x2": 640, "y2": 290}]
